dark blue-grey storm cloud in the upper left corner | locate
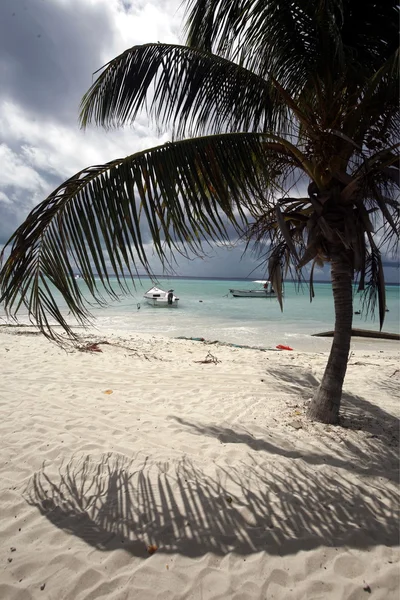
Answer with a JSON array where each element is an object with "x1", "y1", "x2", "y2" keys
[{"x1": 0, "y1": 0, "x2": 113, "y2": 122}]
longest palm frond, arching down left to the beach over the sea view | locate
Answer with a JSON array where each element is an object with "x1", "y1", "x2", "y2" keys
[{"x1": 0, "y1": 134, "x2": 294, "y2": 338}]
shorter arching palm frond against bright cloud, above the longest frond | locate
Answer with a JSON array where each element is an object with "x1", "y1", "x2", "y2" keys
[{"x1": 80, "y1": 44, "x2": 288, "y2": 136}]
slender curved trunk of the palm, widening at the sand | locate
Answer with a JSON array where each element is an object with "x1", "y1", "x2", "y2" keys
[{"x1": 307, "y1": 254, "x2": 353, "y2": 424}]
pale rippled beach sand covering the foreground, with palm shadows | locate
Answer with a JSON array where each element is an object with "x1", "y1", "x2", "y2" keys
[{"x1": 0, "y1": 328, "x2": 400, "y2": 600}]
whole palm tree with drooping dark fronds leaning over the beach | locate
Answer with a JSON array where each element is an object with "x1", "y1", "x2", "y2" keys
[{"x1": 1, "y1": 0, "x2": 399, "y2": 423}]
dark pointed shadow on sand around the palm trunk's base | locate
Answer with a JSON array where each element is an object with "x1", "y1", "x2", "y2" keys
[{"x1": 171, "y1": 366, "x2": 399, "y2": 482}]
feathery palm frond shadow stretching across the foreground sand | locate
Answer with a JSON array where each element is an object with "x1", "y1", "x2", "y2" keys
[{"x1": 24, "y1": 453, "x2": 399, "y2": 557}]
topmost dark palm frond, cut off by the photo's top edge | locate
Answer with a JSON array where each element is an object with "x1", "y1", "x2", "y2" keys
[{"x1": 186, "y1": 0, "x2": 318, "y2": 89}]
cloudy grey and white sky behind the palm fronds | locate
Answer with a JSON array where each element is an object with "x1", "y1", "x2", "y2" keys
[{"x1": 0, "y1": 0, "x2": 398, "y2": 281}]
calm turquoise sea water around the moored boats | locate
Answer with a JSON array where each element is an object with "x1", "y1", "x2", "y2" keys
[{"x1": 7, "y1": 278, "x2": 400, "y2": 351}]
